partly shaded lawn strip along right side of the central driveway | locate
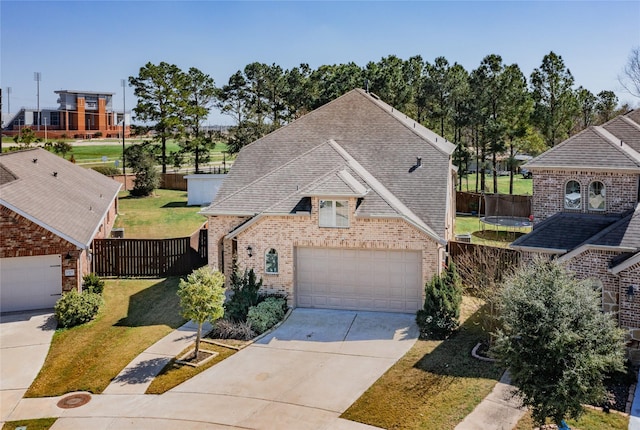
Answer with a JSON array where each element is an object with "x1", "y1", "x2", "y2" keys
[{"x1": 342, "y1": 297, "x2": 502, "y2": 429}]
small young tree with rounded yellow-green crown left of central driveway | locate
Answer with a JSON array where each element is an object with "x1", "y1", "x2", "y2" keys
[{"x1": 178, "y1": 266, "x2": 225, "y2": 357}]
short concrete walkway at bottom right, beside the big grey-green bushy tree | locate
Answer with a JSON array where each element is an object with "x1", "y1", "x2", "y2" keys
[{"x1": 456, "y1": 372, "x2": 526, "y2": 430}]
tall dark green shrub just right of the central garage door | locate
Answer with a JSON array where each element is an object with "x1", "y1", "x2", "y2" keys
[{"x1": 416, "y1": 263, "x2": 462, "y2": 339}]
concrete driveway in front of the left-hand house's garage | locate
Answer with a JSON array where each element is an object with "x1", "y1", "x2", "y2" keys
[{"x1": 0, "y1": 311, "x2": 56, "y2": 422}]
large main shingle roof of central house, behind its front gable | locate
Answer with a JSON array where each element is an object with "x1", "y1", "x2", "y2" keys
[{"x1": 202, "y1": 90, "x2": 454, "y2": 237}]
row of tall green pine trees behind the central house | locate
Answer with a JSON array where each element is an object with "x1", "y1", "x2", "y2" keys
[{"x1": 129, "y1": 52, "x2": 629, "y2": 192}]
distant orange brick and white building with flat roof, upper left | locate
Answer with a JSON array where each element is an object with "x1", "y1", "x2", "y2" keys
[{"x1": 3, "y1": 90, "x2": 131, "y2": 139}]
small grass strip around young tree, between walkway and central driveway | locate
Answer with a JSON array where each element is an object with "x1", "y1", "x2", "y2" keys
[{"x1": 145, "y1": 342, "x2": 237, "y2": 394}]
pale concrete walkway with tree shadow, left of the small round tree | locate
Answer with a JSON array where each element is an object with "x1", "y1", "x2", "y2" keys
[{"x1": 103, "y1": 321, "x2": 212, "y2": 394}]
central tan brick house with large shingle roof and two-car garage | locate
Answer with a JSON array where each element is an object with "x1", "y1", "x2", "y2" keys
[{"x1": 201, "y1": 90, "x2": 455, "y2": 312}]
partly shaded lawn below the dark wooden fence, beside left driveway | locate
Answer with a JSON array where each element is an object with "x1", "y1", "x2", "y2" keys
[{"x1": 26, "y1": 278, "x2": 185, "y2": 397}]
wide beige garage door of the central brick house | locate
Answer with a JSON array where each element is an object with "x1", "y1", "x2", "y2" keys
[{"x1": 296, "y1": 248, "x2": 424, "y2": 312}]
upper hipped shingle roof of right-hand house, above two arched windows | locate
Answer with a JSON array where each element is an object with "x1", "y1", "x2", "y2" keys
[{"x1": 525, "y1": 111, "x2": 640, "y2": 172}]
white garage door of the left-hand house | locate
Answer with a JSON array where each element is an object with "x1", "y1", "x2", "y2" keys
[{"x1": 0, "y1": 255, "x2": 62, "y2": 312}]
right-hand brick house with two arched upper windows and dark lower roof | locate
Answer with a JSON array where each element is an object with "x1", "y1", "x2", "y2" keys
[{"x1": 512, "y1": 110, "x2": 640, "y2": 361}]
